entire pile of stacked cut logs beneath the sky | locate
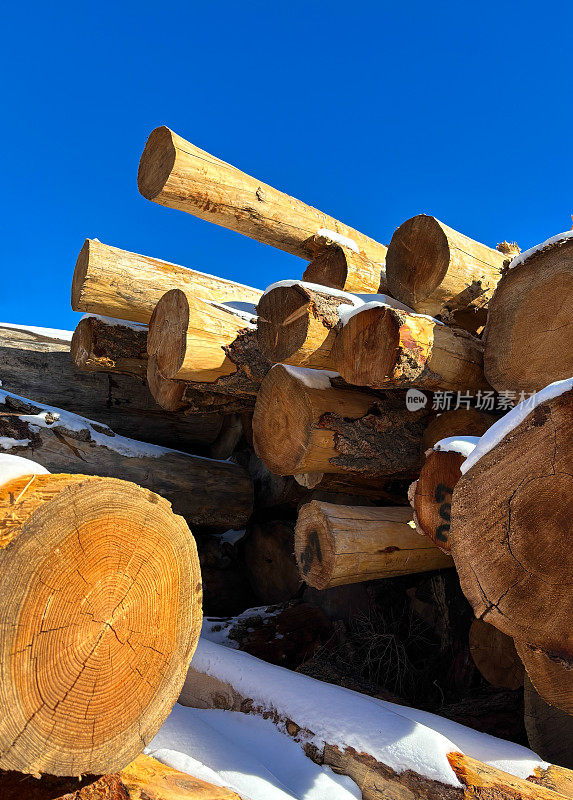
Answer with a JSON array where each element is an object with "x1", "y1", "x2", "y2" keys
[{"x1": 0, "y1": 128, "x2": 573, "y2": 800}]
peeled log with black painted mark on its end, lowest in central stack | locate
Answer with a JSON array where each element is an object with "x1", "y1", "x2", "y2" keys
[{"x1": 294, "y1": 501, "x2": 453, "y2": 589}]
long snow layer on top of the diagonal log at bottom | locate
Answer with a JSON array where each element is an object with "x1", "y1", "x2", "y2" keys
[{"x1": 187, "y1": 637, "x2": 547, "y2": 786}]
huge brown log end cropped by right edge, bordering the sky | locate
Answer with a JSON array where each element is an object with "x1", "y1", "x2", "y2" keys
[{"x1": 484, "y1": 231, "x2": 573, "y2": 392}]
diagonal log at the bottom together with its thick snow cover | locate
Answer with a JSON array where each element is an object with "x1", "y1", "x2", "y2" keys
[{"x1": 179, "y1": 637, "x2": 559, "y2": 800}]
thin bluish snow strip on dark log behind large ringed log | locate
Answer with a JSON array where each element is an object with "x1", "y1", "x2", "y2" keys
[{"x1": 0, "y1": 389, "x2": 228, "y2": 461}]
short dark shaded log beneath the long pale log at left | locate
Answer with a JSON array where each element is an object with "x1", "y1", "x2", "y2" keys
[{"x1": 70, "y1": 314, "x2": 147, "y2": 378}]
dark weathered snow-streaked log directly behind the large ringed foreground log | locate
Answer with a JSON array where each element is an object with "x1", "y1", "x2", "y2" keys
[{"x1": 0, "y1": 390, "x2": 253, "y2": 528}]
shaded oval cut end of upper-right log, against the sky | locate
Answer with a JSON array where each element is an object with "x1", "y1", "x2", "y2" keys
[{"x1": 386, "y1": 214, "x2": 450, "y2": 308}]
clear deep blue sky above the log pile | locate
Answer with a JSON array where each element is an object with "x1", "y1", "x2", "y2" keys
[{"x1": 0, "y1": 0, "x2": 573, "y2": 328}]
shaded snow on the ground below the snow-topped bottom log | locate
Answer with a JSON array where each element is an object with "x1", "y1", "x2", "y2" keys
[{"x1": 144, "y1": 704, "x2": 361, "y2": 800}]
